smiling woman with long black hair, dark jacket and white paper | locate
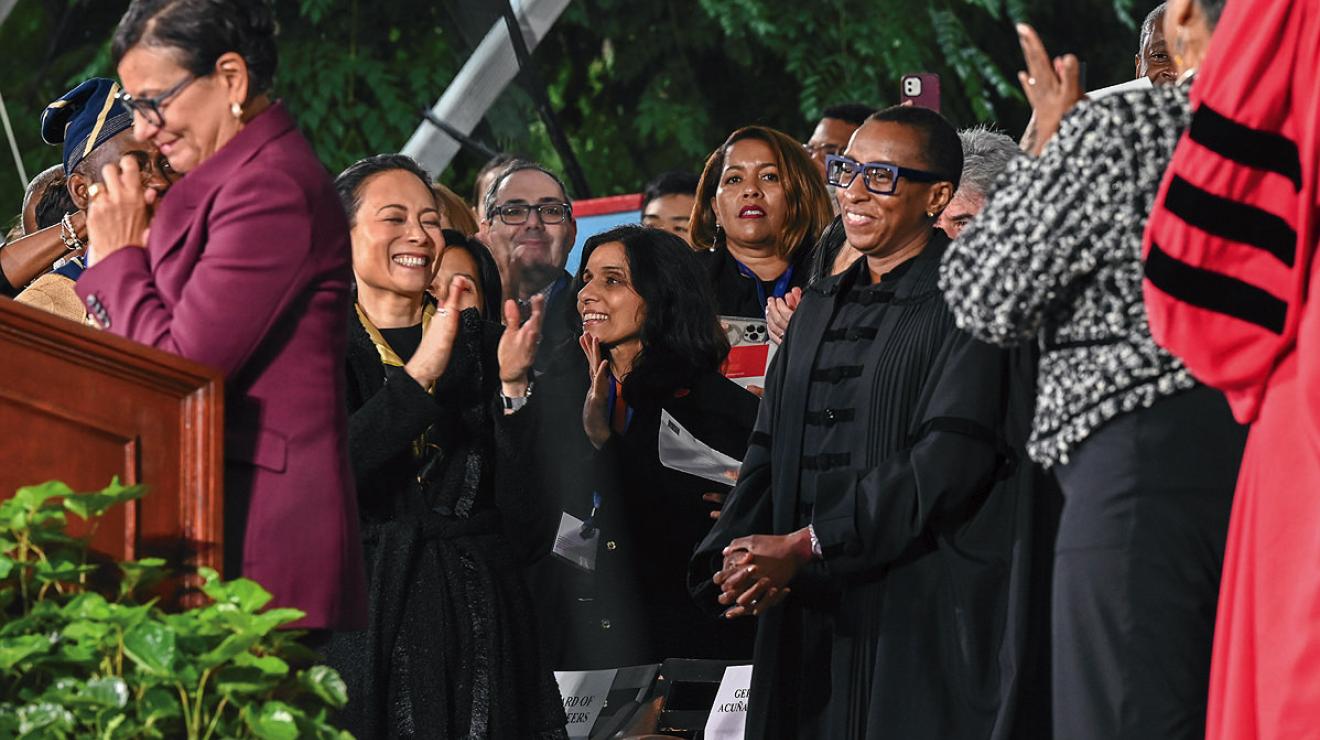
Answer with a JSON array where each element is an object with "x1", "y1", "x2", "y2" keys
[{"x1": 546, "y1": 227, "x2": 758, "y2": 669}]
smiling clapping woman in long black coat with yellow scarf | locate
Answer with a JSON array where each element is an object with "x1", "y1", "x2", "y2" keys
[{"x1": 325, "y1": 156, "x2": 565, "y2": 739}]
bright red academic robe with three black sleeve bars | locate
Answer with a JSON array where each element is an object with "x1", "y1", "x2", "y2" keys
[{"x1": 1144, "y1": 0, "x2": 1320, "y2": 740}]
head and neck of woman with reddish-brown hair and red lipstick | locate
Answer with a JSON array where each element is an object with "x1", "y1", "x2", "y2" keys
[{"x1": 692, "y1": 125, "x2": 833, "y2": 318}]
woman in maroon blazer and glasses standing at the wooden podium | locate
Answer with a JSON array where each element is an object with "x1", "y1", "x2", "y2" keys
[{"x1": 78, "y1": 0, "x2": 366, "y2": 628}]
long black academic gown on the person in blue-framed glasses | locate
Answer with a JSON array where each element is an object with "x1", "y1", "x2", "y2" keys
[{"x1": 689, "y1": 232, "x2": 1032, "y2": 740}]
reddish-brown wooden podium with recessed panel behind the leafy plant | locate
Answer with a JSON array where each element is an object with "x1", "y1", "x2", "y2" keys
[{"x1": 0, "y1": 298, "x2": 224, "y2": 572}]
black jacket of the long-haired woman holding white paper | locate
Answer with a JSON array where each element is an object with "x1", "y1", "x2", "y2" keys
[{"x1": 533, "y1": 364, "x2": 759, "y2": 670}]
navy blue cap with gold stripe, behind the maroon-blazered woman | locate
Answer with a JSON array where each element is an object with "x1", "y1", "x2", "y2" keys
[{"x1": 41, "y1": 77, "x2": 133, "y2": 177}]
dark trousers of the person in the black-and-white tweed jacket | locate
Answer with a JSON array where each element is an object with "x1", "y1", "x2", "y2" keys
[{"x1": 1052, "y1": 388, "x2": 1246, "y2": 740}]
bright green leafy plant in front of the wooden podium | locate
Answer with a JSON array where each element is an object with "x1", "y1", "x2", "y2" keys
[{"x1": 0, "y1": 479, "x2": 348, "y2": 740}]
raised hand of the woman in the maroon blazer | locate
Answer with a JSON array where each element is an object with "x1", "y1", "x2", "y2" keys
[{"x1": 87, "y1": 154, "x2": 156, "y2": 265}]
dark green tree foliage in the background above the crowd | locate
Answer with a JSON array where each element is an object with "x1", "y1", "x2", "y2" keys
[{"x1": 0, "y1": 0, "x2": 1155, "y2": 218}]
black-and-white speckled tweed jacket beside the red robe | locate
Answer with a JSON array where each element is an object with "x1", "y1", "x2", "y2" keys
[{"x1": 940, "y1": 86, "x2": 1196, "y2": 466}]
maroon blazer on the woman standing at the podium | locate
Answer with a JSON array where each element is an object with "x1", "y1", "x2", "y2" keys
[{"x1": 77, "y1": 103, "x2": 367, "y2": 629}]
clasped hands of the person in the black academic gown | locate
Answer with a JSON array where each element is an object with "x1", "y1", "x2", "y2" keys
[{"x1": 711, "y1": 528, "x2": 812, "y2": 619}]
